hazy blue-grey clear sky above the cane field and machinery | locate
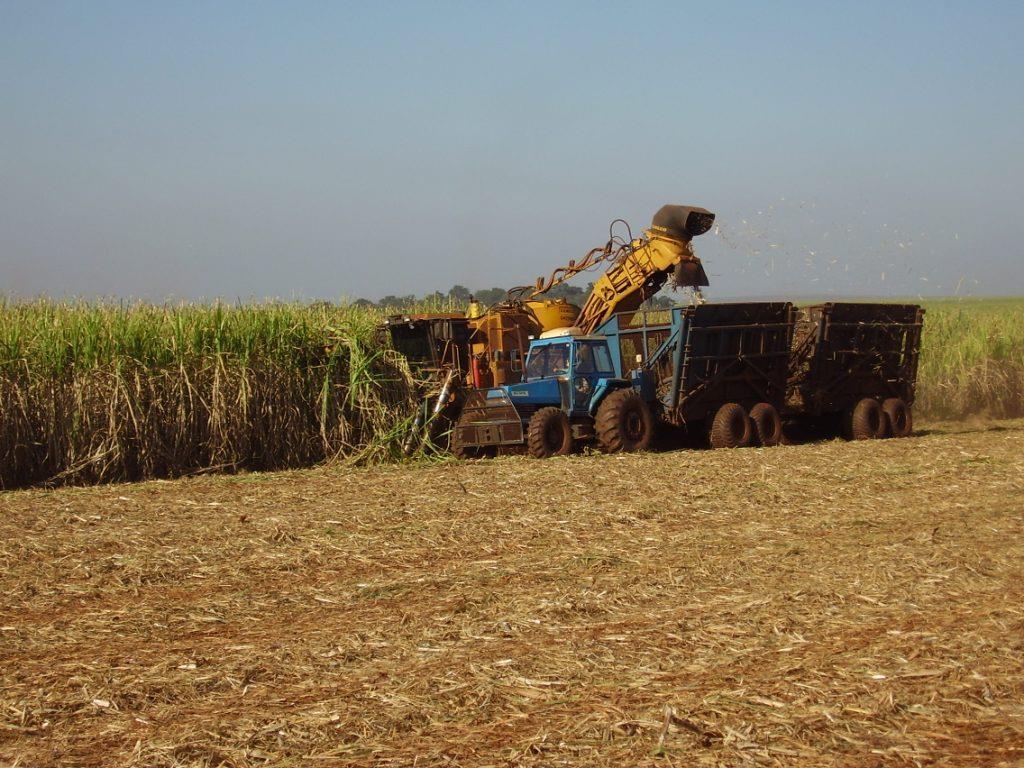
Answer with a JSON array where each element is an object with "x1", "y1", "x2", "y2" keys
[{"x1": 0, "y1": 0, "x2": 1024, "y2": 301}]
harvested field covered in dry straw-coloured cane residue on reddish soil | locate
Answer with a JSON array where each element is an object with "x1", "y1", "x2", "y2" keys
[{"x1": 0, "y1": 422, "x2": 1024, "y2": 766}]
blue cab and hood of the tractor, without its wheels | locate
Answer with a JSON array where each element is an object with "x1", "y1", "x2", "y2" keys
[{"x1": 504, "y1": 335, "x2": 616, "y2": 416}]
